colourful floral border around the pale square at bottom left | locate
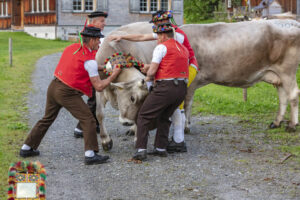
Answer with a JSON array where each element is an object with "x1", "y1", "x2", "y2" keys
[{"x1": 7, "y1": 161, "x2": 46, "y2": 200}]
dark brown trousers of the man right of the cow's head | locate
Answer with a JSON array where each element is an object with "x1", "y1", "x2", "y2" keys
[{"x1": 136, "y1": 80, "x2": 187, "y2": 149}]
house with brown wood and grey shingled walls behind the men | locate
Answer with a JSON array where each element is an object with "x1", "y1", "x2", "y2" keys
[{"x1": 0, "y1": 0, "x2": 183, "y2": 39}]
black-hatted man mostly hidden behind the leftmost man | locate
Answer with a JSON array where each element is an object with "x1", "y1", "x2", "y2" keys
[{"x1": 74, "y1": 11, "x2": 108, "y2": 138}]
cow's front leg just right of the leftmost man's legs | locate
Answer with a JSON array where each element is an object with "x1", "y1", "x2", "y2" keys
[{"x1": 96, "y1": 92, "x2": 113, "y2": 151}]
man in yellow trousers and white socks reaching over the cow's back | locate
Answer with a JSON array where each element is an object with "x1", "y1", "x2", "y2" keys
[{"x1": 110, "y1": 10, "x2": 199, "y2": 153}]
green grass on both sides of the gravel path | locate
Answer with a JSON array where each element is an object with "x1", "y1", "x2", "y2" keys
[{"x1": 0, "y1": 28, "x2": 300, "y2": 199}]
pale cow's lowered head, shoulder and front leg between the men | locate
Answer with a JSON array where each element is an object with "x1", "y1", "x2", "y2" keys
[{"x1": 96, "y1": 23, "x2": 156, "y2": 150}]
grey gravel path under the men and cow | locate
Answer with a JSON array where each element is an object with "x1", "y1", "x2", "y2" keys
[{"x1": 28, "y1": 53, "x2": 300, "y2": 200}]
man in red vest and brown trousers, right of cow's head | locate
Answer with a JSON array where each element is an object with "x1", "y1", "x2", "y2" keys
[{"x1": 133, "y1": 23, "x2": 189, "y2": 160}]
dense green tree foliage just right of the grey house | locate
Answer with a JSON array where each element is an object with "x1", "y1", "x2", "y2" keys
[{"x1": 184, "y1": 0, "x2": 222, "y2": 22}]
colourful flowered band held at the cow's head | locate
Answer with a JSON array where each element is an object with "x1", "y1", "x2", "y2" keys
[{"x1": 103, "y1": 52, "x2": 144, "y2": 76}]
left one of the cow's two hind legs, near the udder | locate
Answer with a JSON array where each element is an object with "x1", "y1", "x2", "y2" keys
[{"x1": 270, "y1": 86, "x2": 288, "y2": 128}]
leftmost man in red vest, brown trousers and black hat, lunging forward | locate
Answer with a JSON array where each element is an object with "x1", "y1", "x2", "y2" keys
[{"x1": 20, "y1": 26, "x2": 120, "y2": 165}]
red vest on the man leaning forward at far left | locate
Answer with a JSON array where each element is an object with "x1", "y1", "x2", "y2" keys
[{"x1": 54, "y1": 43, "x2": 95, "y2": 97}]
